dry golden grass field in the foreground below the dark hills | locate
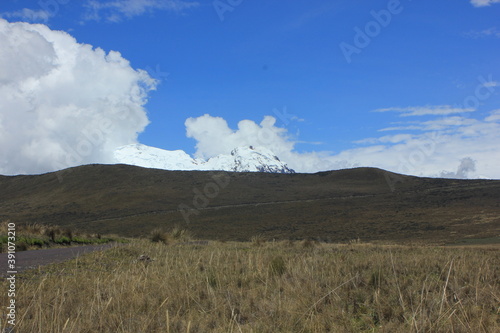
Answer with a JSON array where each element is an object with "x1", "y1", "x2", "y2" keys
[{"x1": 0, "y1": 239, "x2": 500, "y2": 333}]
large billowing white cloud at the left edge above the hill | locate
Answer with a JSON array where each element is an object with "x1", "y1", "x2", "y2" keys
[{"x1": 0, "y1": 19, "x2": 156, "y2": 174}]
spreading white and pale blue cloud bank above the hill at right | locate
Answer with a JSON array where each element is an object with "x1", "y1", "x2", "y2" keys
[{"x1": 348, "y1": 110, "x2": 500, "y2": 178}]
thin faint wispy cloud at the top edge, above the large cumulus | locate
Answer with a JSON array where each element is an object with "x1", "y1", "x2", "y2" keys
[{"x1": 83, "y1": 0, "x2": 199, "y2": 22}]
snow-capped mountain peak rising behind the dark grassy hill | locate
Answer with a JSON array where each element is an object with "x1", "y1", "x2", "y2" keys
[{"x1": 114, "y1": 144, "x2": 295, "y2": 173}]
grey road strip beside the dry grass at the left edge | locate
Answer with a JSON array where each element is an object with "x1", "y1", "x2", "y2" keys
[{"x1": 0, "y1": 243, "x2": 116, "y2": 276}]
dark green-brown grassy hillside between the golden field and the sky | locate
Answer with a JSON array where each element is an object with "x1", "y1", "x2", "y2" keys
[{"x1": 0, "y1": 165, "x2": 500, "y2": 242}]
